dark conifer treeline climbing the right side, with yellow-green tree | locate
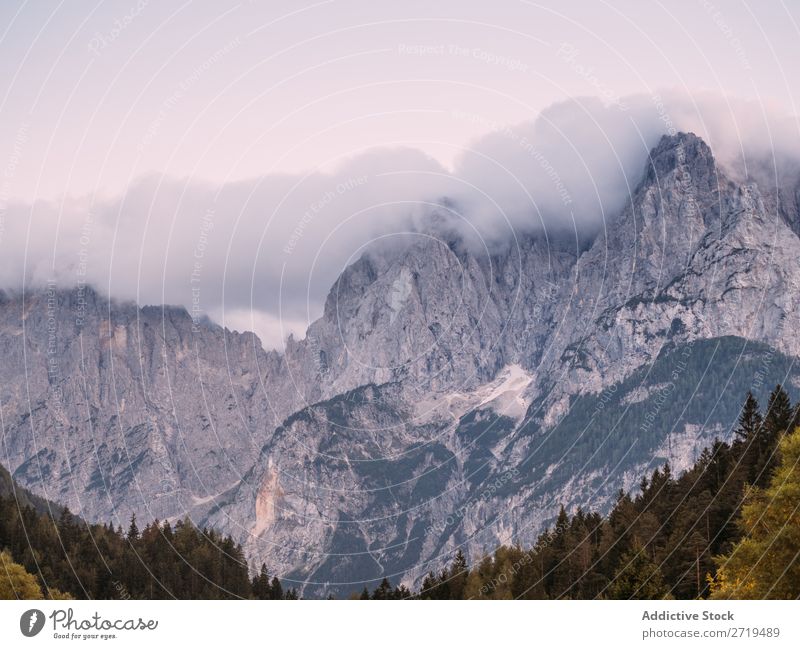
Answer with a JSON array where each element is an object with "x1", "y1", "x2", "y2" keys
[{"x1": 417, "y1": 386, "x2": 800, "y2": 599}]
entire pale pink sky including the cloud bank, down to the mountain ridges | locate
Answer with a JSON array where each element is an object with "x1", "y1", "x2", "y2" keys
[{"x1": 0, "y1": 0, "x2": 800, "y2": 347}]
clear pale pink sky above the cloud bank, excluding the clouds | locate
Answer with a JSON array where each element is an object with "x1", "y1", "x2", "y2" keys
[{"x1": 0, "y1": 0, "x2": 800, "y2": 201}]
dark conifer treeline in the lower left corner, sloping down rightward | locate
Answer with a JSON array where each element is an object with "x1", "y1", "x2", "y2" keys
[{"x1": 0, "y1": 496, "x2": 297, "y2": 599}]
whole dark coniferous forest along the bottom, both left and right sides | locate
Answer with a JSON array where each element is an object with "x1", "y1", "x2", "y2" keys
[{"x1": 0, "y1": 386, "x2": 800, "y2": 599}]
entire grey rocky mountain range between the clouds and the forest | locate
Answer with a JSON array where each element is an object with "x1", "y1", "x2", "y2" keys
[{"x1": 0, "y1": 134, "x2": 800, "y2": 595}]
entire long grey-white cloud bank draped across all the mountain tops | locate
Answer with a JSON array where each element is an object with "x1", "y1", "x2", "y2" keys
[{"x1": 0, "y1": 92, "x2": 800, "y2": 346}]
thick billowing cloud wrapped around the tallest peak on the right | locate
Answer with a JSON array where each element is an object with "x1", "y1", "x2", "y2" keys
[{"x1": 444, "y1": 91, "x2": 800, "y2": 246}]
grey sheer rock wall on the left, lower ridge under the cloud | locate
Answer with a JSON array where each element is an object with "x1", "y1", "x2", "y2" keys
[{"x1": 0, "y1": 287, "x2": 302, "y2": 520}]
